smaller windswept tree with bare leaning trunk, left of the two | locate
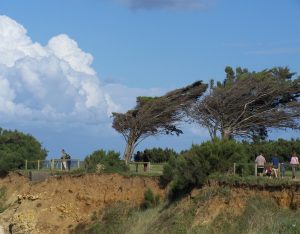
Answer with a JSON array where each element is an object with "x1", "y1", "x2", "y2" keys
[{"x1": 113, "y1": 81, "x2": 207, "y2": 161}]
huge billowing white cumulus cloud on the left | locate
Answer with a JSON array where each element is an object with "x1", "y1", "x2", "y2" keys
[{"x1": 0, "y1": 16, "x2": 119, "y2": 123}]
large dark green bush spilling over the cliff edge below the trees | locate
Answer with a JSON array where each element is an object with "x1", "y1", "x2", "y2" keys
[{"x1": 162, "y1": 139, "x2": 248, "y2": 199}]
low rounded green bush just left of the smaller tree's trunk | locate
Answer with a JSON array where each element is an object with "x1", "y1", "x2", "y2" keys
[{"x1": 84, "y1": 149, "x2": 129, "y2": 172}]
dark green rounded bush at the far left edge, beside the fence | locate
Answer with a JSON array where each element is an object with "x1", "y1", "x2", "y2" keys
[{"x1": 0, "y1": 129, "x2": 47, "y2": 174}]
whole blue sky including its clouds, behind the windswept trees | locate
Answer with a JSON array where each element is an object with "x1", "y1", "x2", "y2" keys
[{"x1": 0, "y1": 0, "x2": 300, "y2": 158}]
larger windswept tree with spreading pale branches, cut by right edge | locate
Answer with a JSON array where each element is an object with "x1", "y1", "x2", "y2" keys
[{"x1": 189, "y1": 67, "x2": 300, "y2": 138}]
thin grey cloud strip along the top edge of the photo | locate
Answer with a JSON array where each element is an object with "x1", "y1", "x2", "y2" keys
[{"x1": 116, "y1": 0, "x2": 212, "y2": 10}]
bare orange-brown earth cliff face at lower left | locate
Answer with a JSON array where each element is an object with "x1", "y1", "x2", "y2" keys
[{"x1": 0, "y1": 173, "x2": 165, "y2": 234}]
